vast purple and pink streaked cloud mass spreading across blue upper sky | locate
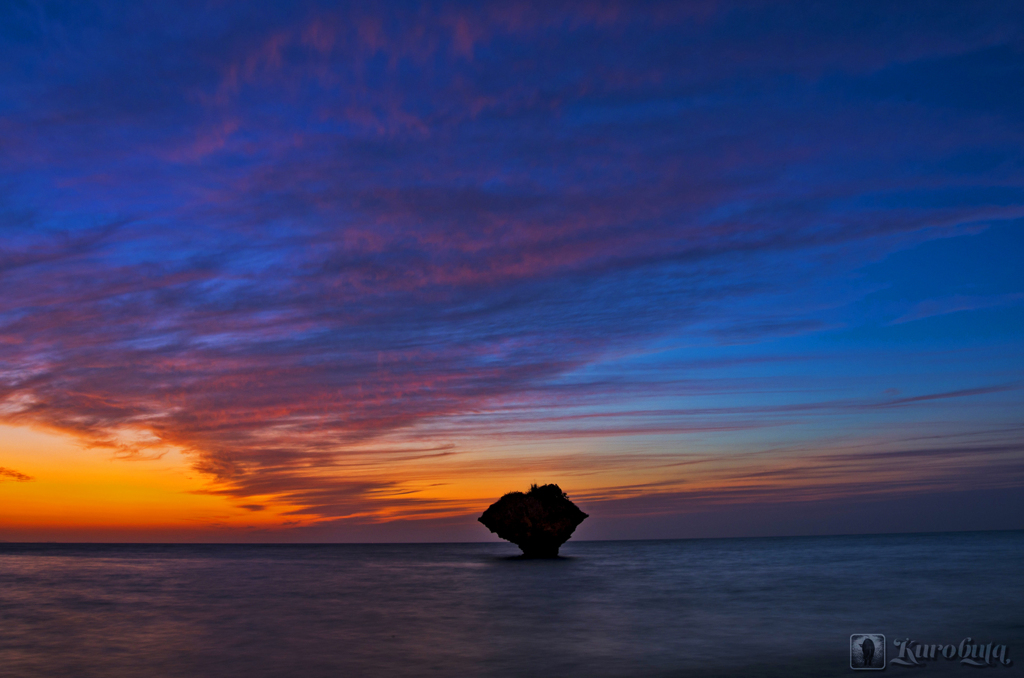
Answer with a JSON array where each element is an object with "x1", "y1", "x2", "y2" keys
[{"x1": 0, "y1": 2, "x2": 1024, "y2": 517}]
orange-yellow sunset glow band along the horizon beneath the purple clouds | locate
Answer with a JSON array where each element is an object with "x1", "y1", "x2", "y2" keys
[{"x1": 0, "y1": 425, "x2": 1009, "y2": 542}]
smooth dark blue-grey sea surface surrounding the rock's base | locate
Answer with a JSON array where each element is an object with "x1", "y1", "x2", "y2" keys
[{"x1": 0, "y1": 533, "x2": 1024, "y2": 678}]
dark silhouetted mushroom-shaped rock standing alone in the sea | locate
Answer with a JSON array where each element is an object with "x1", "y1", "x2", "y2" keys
[{"x1": 477, "y1": 484, "x2": 587, "y2": 558}]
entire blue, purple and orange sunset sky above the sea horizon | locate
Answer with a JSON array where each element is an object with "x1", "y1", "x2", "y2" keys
[{"x1": 0, "y1": 0, "x2": 1024, "y2": 542}]
